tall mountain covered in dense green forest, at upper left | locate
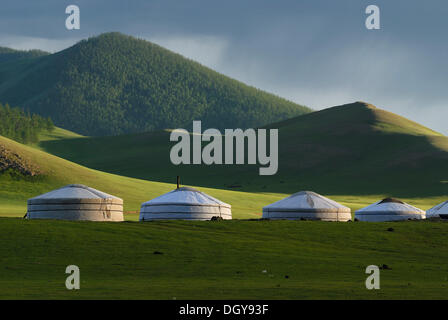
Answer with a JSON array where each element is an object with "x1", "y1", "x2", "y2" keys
[{"x1": 0, "y1": 33, "x2": 310, "y2": 135}]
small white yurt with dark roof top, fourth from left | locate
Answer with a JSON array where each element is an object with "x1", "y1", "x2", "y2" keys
[{"x1": 355, "y1": 198, "x2": 426, "y2": 222}]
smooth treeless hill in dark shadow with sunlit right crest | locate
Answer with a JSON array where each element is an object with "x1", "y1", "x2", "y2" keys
[{"x1": 37, "y1": 103, "x2": 448, "y2": 208}]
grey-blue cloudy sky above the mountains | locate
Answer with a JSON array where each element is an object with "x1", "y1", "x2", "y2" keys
[{"x1": 0, "y1": 0, "x2": 448, "y2": 134}]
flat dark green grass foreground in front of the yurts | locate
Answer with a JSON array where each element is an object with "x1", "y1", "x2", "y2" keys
[{"x1": 0, "y1": 218, "x2": 448, "y2": 299}]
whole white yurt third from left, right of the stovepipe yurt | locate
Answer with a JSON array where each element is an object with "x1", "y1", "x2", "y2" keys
[{"x1": 263, "y1": 191, "x2": 352, "y2": 221}]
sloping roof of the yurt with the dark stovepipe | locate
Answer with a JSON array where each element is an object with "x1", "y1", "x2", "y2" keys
[{"x1": 142, "y1": 187, "x2": 231, "y2": 208}]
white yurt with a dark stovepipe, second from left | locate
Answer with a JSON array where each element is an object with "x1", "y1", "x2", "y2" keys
[{"x1": 140, "y1": 187, "x2": 232, "y2": 221}]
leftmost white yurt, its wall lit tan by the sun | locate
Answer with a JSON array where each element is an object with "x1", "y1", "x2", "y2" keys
[{"x1": 26, "y1": 184, "x2": 123, "y2": 221}]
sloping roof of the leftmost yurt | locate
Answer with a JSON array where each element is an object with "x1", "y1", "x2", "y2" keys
[{"x1": 28, "y1": 184, "x2": 123, "y2": 204}]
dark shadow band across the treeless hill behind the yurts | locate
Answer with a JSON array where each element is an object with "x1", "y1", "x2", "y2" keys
[{"x1": 41, "y1": 128, "x2": 448, "y2": 198}]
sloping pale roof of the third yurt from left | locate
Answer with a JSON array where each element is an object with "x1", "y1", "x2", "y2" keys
[{"x1": 263, "y1": 191, "x2": 351, "y2": 212}]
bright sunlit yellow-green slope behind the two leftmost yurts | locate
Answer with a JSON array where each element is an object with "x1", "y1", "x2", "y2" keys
[{"x1": 0, "y1": 129, "x2": 288, "y2": 220}]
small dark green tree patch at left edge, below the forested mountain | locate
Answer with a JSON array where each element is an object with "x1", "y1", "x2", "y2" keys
[{"x1": 0, "y1": 103, "x2": 54, "y2": 143}]
